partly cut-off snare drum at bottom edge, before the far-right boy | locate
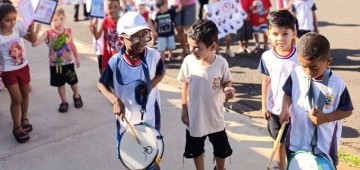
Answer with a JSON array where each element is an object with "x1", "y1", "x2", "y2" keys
[{"x1": 287, "y1": 151, "x2": 336, "y2": 170}]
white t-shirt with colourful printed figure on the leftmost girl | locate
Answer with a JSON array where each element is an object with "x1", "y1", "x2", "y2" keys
[{"x1": 0, "y1": 22, "x2": 28, "y2": 71}]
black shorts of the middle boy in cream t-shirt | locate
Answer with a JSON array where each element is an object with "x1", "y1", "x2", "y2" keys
[{"x1": 184, "y1": 129, "x2": 232, "y2": 158}]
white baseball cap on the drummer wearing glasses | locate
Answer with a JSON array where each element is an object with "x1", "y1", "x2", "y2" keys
[{"x1": 116, "y1": 12, "x2": 150, "y2": 35}]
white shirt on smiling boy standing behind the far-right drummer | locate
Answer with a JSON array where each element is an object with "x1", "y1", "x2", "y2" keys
[{"x1": 258, "y1": 46, "x2": 298, "y2": 115}]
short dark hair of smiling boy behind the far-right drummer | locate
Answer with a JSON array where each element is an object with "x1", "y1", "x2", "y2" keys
[{"x1": 267, "y1": 9, "x2": 296, "y2": 31}]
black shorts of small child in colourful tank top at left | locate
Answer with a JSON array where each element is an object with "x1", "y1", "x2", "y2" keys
[{"x1": 50, "y1": 63, "x2": 78, "y2": 87}]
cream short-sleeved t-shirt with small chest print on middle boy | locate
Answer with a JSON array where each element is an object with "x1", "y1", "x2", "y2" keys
[{"x1": 178, "y1": 55, "x2": 232, "y2": 137}]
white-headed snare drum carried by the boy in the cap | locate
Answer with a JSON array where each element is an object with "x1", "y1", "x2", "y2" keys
[{"x1": 119, "y1": 123, "x2": 164, "y2": 169}]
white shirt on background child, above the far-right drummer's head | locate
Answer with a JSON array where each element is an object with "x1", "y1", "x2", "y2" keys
[{"x1": 292, "y1": 0, "x2": 316, "y2": 31}]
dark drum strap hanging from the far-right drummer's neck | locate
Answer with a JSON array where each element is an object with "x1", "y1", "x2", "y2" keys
[{"x1": 308, "y1": 69, "x2": 330, "y2": 154}]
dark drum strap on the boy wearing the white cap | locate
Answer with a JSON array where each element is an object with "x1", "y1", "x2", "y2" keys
[{"x1": 116, "y1": 47, "x2": 151, "y2": 120}]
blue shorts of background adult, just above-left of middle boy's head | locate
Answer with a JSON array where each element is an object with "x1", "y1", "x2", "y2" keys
[{"x1": 174, "y1": 3, "x2": 196, "y2": 26}]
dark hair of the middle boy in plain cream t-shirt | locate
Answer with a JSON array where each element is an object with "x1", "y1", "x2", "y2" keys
[{"x1": 187, "y1": 19, "x2": 219, "y2": 47}]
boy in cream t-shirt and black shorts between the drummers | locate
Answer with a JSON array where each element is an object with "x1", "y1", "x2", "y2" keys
[{"x1": 178, "y1": 20, "x2": 235, "y2": 170}]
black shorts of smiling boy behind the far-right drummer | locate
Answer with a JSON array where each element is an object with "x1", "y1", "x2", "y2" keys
[{"x1": 267, "y1": 112, "x2": 289, "y2": 143}]
